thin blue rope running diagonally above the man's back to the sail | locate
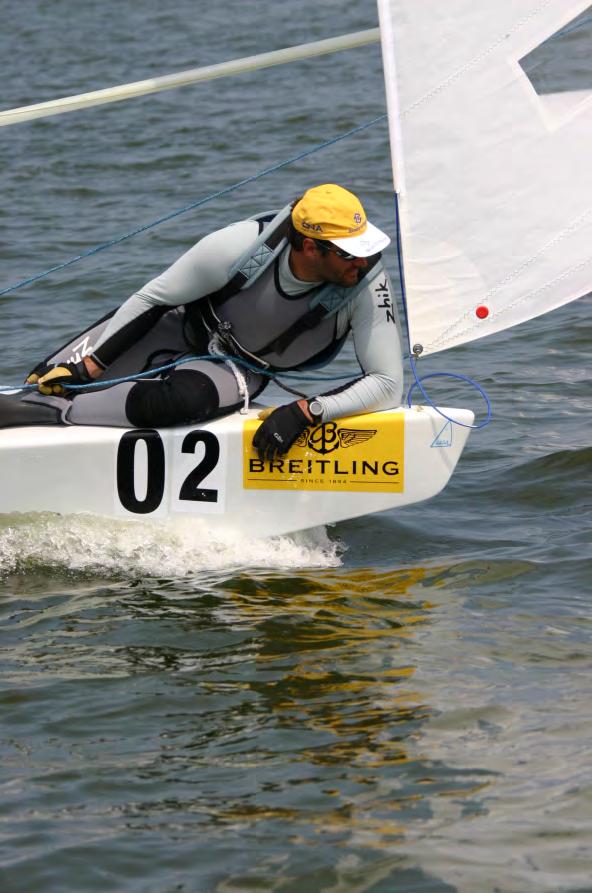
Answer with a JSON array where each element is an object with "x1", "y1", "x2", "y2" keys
[{"x1": 0, "y1": 115, "x2": 386, "y2": 297}]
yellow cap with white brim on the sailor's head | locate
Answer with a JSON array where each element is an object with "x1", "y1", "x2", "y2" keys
[{"x1": 292, "y1": 183, "x2": 390, "y2": 257}]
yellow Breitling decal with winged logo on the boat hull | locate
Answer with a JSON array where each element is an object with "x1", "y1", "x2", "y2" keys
[{"x1": 243, "y1": 412, "x2": 405, "y2": 493}]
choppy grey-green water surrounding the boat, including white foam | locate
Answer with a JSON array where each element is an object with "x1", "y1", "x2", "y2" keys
[{"x1": 0, "y1": 0, "x2": 592, "y2": 893}]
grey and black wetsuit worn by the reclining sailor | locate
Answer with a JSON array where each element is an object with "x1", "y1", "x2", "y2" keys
[{"x1": 41, "y1": 220, "x2": 403, "y2": 427}]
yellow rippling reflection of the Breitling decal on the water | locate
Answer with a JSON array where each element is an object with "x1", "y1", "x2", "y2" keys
[{"x1": 169, "y1": 567, "x2": 486, "y2": 860}]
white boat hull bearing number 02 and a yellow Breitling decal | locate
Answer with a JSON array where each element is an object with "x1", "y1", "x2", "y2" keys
[{"x1": 0, "y1": 407, "x2": 473, "y2": 536}]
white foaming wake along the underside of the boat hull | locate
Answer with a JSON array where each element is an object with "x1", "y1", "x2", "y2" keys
[{"x1": 0, "y1": 514, "x2": 343, "y2": 578}]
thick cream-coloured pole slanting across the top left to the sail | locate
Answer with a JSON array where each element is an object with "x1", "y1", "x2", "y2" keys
[{"x1": 0, "y1": 28, "x2": 380, "y2": 127}]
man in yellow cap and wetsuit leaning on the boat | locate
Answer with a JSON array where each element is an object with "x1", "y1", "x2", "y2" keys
[{"x1": 27, "y1": 184, "x2": 403, "y2": 458}]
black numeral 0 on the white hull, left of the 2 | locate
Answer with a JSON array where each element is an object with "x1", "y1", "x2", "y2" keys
[{"x1": 117, "y1": 429, "x2": 164, "y2": 515}]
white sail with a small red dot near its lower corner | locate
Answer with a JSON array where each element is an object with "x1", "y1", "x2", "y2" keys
[{"x1": 378, "y1": 0, "x2": 592, "y2": 354}]
